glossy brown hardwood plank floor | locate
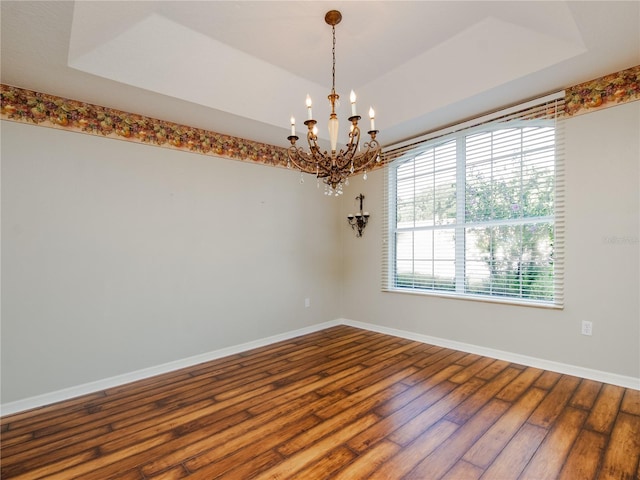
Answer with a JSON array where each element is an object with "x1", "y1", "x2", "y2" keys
[{"x1": 1, "y1": 326, "x2": 640, "y2": 480}]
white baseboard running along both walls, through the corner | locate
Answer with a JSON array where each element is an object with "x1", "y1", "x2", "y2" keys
[{"x1": 0, "y1": 318, "x2": 640, "y2": 415}]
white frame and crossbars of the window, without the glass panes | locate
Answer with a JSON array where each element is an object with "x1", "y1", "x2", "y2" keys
[{"x1": 382, "y1": 92, "x2": 564, "y2": 308}]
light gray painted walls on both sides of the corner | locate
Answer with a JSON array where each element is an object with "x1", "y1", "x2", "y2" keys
[{"x1": 1, "y1": 102, "x2": 640, "y2": 403}]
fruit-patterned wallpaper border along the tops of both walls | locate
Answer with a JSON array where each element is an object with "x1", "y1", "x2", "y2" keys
[{"x1": 0, "y1": 65, "x2": 640, "y2": 168}]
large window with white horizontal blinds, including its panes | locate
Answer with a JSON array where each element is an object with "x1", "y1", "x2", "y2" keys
[{"x1": 383, "y1": 95, "x2": 563, "y2": 306}]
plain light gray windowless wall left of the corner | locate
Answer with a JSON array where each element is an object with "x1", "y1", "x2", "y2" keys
[{"x1": 1, "y1": 121, "x2": 343, "y2": 403}]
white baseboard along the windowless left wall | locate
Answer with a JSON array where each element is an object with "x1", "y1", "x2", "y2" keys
[{"x1": 0, "y1": 320, "x2": 340, "y2": 416}]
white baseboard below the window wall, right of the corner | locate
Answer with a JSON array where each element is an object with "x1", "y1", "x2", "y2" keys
[{"x1": 339, "y1": 318, "x2": 640, "y2": 390}]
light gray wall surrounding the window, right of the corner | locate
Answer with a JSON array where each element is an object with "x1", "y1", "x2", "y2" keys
[{"x1": 342, "y1": 102, "x2": 640, "y2": 378}]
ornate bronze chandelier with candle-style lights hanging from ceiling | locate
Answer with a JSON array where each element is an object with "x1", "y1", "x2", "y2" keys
[{"x1": 287, "y1": 10, "x2": 381, "y2": 196}]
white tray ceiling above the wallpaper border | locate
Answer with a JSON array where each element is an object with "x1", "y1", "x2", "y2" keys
[{"x1": 1, "y1": 0, "x2": 640, "y2": 146}]
